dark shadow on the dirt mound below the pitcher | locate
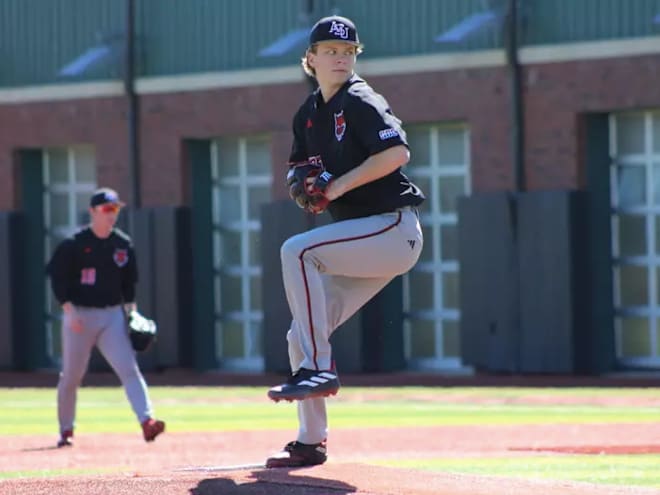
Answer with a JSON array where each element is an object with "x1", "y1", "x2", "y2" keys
[{"x1": 190, "y1": 469, "x2": 357, "y2": 495}]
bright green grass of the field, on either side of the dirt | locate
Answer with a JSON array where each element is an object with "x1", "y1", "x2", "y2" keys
[{"x1": 0, "y1": 387, "x2": 660, "y2": 488}]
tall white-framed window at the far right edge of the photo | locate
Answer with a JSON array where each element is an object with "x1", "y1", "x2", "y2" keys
[{"x1": 610, "y1": 111, "x2": 660, "y2": 367}]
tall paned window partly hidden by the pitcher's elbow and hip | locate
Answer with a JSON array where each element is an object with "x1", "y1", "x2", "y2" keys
[{"x1": 404, "y1": 125, "x2": 470, "y2": 369}]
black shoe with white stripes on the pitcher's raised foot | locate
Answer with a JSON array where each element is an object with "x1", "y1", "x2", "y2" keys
[{"x1": 268, "y1": 368, "x2": 340, "y2": 402}]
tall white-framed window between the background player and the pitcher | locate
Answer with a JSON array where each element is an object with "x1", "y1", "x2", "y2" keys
[{"x1": 211, "y1": 137, "x2": 272, "y2": 371}]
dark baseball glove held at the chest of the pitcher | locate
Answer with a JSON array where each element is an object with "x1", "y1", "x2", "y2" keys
[{"x1": 286, "y1": 162, "x2": 334, "y2": 215}]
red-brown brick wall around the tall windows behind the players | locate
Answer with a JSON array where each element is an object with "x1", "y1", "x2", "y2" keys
[{"x1": 0, "y1": 56, "x2": 660, "y2": 210}]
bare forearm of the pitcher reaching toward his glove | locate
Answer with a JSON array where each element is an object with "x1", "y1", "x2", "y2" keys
[{"x1": 326, "y1": 144, "x2": 410, "y2": 201}]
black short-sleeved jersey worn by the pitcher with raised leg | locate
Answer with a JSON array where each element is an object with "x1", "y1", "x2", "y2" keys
[{"x1": 289, "y1": 75, "x2": 424, "y2": 220}]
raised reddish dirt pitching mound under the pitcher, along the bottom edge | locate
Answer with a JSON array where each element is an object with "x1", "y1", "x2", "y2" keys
[{"x1": 5, "y1": 464, "x2": 657, "y2": 495}]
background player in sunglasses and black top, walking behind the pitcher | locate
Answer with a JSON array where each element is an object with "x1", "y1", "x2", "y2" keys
[{"x1": 48, "y1": 188, "x2": 165, "y2": 447}]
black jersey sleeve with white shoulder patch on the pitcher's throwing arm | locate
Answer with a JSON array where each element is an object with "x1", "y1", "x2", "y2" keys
[{"x1": 347, "y1": 91, "x2": 408, "y2": 155}]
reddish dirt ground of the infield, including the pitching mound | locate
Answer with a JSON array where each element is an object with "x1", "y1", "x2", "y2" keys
[{"x1": 0, "y1": 424, "x2": 660, "y2": 495}]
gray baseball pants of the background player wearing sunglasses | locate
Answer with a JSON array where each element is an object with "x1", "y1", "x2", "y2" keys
[{"x1": 57, "y1": 306, "x2": 152, "y2": 431}]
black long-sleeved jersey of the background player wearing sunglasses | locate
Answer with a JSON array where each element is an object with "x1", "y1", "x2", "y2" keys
[{"x1": 48, "y1": 227, "x2": 137, "y2": 308}]
